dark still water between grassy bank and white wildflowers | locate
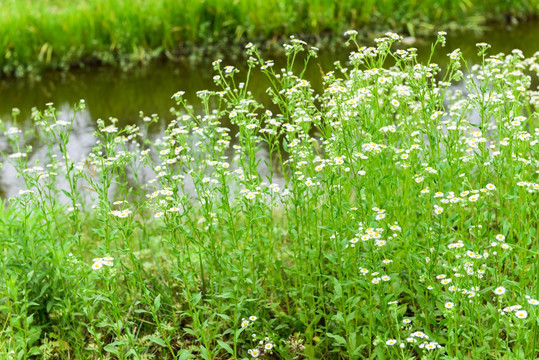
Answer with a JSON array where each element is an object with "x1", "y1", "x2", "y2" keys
[{"x1": 0, "y1": 22, "x2": 539, "y2": 198}]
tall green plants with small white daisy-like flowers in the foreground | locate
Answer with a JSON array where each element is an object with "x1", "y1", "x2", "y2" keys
[{"x1": 0, "y1": 32, "x2": 539, "y2": 360}]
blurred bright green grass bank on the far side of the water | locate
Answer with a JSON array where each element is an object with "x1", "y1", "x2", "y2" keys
[{"x1": 0, "y1": 0, "x2": 539, "y2": 76}]
